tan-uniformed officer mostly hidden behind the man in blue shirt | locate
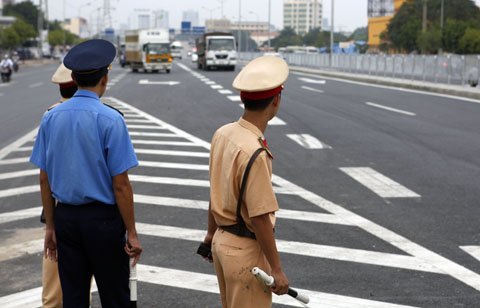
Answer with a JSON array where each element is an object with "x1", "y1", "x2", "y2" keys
[{"x1": 41, "y1": 63, "x2": 78, "y2": 308}]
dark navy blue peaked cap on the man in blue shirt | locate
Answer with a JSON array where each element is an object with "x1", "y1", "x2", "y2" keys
[{"x1": 63, "y1": 39, "x2": 117, "y2": 75}]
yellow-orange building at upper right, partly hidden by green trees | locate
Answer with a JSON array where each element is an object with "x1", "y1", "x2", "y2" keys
[{"x1": 368, "y1": 0, "x2": 407, "y2": 48}]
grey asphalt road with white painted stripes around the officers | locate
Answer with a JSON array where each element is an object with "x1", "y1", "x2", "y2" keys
[{"x1": 0, "y1": 59, "x2": 480, "y2": 307}]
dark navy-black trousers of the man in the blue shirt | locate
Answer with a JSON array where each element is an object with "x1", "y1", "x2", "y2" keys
[{"x1": 55, "y1": 203, "x2": 130, "y2": 308}]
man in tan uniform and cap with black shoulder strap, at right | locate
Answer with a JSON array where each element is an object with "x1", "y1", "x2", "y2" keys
[{"x1": 202, "y1": 56, "x2": 289, "y2": 308}]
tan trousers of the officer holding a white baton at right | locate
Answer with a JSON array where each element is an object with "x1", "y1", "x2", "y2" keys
[{"x1": 212, "y1": 229, "x2": 272, "y2": 308}]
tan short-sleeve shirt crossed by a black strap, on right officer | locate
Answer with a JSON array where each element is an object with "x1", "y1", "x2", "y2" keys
[{"x1": 210, "y1": 118, "x2": 278, "y2": 230}]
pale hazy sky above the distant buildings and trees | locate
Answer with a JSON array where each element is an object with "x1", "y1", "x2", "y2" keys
[{"x1": 26, "y1": 0, "x2": 480, "y2": 31}]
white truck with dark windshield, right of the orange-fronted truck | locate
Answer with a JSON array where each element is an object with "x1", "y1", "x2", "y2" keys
[{"x1": 196, "y1": 32, "x2": 237, "y2": 71}]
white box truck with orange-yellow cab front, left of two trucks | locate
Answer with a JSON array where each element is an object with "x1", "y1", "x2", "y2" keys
[{"x1": 125, "y1": 29, "x2": 172, "y2": 73}]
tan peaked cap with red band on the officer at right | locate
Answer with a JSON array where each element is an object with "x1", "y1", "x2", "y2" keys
[{"x1": 232, "y1": 56, "x2": 289, "y2": 100}]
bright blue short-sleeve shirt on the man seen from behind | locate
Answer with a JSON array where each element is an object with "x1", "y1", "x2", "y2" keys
[{"x1": 30, "y1": 90, "x2": 138, "y2": 204}]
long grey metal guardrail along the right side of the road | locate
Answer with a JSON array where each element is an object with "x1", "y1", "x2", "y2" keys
[{"x1": 240, "y1": 52, "x2": 480, "y2": 85}]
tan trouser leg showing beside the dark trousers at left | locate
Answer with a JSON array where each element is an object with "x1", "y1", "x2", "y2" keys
[{"x1": 42, "y1": 256, "x2": 63, "y2": 308}]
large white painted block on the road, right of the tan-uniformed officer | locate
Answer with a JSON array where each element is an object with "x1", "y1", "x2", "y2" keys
[{"x1": 340, "y1": 167, "x2": 420, "y2": 198}]
